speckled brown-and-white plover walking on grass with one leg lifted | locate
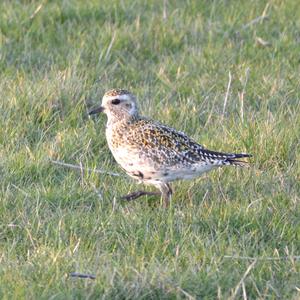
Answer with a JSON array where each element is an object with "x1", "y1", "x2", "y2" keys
[{"x1": 89, "y1": 89, "x2": 251, "y2": 206}]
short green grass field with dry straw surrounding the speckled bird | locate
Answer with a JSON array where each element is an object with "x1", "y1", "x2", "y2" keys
[{"x1": 0, "y1": 0, "x2": 300, "y2": 299}]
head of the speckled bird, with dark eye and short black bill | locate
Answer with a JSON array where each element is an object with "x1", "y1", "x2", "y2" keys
[{"x1": 89, "y1": 89, "x2": 138, "y2": 122}]
